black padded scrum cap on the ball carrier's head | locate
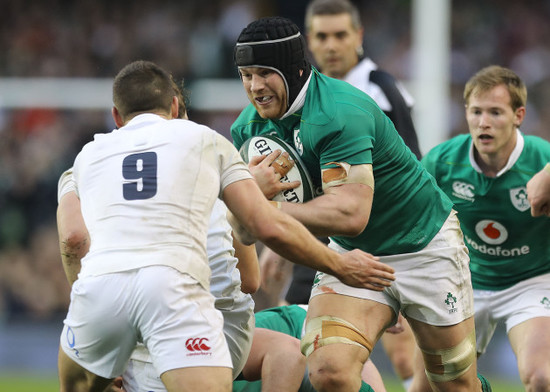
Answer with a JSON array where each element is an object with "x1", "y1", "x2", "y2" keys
[{"x1": 234, "y1": 16, "x2": 311, "y2": 109}]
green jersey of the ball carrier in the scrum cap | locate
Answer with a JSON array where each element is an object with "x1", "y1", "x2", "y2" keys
[{"x1": 231, "y1": 69, "x2": 452, "y2": 256}]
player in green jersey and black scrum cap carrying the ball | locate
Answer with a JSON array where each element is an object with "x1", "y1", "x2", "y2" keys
[{"x1": 231, "y1": 17, "x2": 490, "y2": 392}]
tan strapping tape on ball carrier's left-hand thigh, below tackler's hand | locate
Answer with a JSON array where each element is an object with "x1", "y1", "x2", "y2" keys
[{"x1": 300, "y1": 316, "x2": 372, "y2": 357}]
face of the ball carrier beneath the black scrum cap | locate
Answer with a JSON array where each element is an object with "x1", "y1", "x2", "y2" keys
[{"x1": 244, "y1": 67, "x2": 288, "y2": 119}]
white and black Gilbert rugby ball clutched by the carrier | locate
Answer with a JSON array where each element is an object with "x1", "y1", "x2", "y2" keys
[{"x1": 239, "y1": 135, "x2": 314, "y2": 203}]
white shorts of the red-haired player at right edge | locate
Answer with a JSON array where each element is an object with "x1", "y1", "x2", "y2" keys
[{"x1": 474, "y1": 274, "x2": 550, "y2": 354}]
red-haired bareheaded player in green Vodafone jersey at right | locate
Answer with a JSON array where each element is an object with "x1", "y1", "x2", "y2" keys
[{"x1": 422, "y1": 66, "x2": 550, "y2": 392}]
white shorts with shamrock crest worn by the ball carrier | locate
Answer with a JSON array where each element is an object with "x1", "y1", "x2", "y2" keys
[{"x1": 311, "y1": 211, "x2": 474, "y2": 326}]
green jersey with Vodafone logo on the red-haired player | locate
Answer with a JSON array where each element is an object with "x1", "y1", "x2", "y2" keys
[{"x1": 422, "y1": 131, "x2": 550, "y2": 290}]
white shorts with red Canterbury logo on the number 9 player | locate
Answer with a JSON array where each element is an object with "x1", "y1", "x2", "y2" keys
[{"x1": 60, "y1": 266, "x2": 232, "y2": 378}]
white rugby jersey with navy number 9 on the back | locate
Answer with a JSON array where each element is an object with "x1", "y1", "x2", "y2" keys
[{"x1": 69, "y1": 114, "x2": 252, "y2": 288}]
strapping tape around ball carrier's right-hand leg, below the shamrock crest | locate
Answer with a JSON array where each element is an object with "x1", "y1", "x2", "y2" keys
[{"x1": 422, "y1": 331, "x2": 476, "y2": 382}]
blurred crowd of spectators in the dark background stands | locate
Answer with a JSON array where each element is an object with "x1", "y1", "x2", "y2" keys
[{"x1": 0, "y1": 0, "x2": 550, "y2": 321}]
